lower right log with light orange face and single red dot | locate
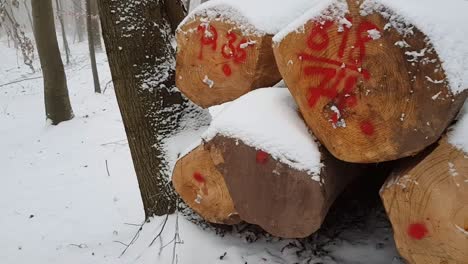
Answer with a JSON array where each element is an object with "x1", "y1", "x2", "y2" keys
[{"x1": 380, "y1": 137, "x2": 468, "y2": 264}]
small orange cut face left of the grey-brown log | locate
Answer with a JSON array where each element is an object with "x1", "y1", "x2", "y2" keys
[{"x1": 172, "y1": 145, "x2": 240, "y2": 225}]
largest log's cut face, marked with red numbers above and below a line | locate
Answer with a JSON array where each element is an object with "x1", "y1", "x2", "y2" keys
[{"x1": 274, "y1": 0, "x2": 467, "y2": 163}]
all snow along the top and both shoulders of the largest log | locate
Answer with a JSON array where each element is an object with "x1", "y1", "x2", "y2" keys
[{"x1": 273, "y1": 0, "x2": 468, "y2": 94}]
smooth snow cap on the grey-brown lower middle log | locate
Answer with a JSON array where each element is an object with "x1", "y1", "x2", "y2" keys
[{"x1": 203, "y1": 88, "x2": 322, "y2": 177}]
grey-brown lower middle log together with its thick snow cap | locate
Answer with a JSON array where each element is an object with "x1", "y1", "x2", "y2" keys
[{"x1": 203, "y1": 88, "x2": 361, "y2": 238}]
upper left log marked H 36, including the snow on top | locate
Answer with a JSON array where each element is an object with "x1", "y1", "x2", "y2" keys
[{"x1": 176, "y1": 0, "x2": 322, "y2": 108}]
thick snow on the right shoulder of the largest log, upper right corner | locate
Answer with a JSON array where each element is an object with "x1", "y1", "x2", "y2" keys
[{"x1": 361, "y1": 0, "x2": 468, "y2": 94}]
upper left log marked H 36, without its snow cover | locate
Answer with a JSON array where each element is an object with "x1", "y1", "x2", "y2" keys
[{"x1": 176, "y1": 16, "x2": 282, "y2": 108}]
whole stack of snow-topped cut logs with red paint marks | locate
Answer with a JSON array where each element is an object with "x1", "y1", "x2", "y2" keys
[{"x1": 173, "y1": 0, "x2": 468, "y2": 264}]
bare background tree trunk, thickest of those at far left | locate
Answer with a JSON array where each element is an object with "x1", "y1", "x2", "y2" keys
[{"x1": 31, "y1": 0, "x2": 73, "y2": 125}]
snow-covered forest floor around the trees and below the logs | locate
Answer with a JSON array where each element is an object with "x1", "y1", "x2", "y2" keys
[{"x1": 0, "y1": 40, "x2": 402, "y2": 264}]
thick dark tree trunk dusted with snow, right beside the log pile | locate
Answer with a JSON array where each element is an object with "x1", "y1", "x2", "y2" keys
[{"x1": 98, "y1": 0, "x2": 184, "y2": 217}]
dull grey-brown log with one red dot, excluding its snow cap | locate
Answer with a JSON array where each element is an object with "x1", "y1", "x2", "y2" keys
[{"x1": 207, "y1": 135, "x2": 361, "y2": 238}]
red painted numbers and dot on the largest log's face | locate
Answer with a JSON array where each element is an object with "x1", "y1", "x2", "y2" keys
[{"x1": 298, "y1": 18, "x2": 379, "y2": 129}]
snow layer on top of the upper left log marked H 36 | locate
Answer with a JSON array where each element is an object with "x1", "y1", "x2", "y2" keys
[{"x1": 179, "y1": 0, "x2": 328, "y2": 36}]
